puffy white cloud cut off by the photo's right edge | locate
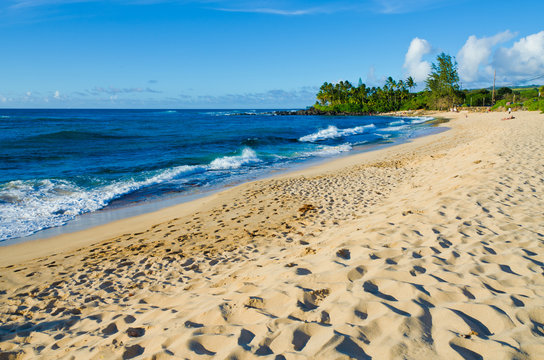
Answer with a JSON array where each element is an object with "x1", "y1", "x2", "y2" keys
[{"x1": 493, "y1": 30, "x2": 544, "y2": 82}]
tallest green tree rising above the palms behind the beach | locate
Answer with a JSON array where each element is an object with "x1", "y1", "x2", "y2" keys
[{"x1": 425, "y1": 53, "x2": 460, "y2": 109}]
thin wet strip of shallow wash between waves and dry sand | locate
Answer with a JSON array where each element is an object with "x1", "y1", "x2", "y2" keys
[{"x1": 0, "y1": 114, "x2": 448, "y2": 252}]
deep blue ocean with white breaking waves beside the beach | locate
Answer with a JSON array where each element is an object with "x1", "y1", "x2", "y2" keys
[{"x1": 0, "y1": 109, "x2": 436, "y2": 241}]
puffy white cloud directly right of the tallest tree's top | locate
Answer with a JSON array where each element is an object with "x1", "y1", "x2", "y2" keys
[{"x1": 457, "y1": 30, "x2": 514, "y2": 82}]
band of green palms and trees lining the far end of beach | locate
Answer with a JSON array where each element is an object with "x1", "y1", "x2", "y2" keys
[{"x1": 307, "y1": 53, "x2": 544, "y2": 115}]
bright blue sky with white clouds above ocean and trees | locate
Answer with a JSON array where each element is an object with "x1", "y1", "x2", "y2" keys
[{"x1": 0, "y1": 0, "x2": 544, "y2": 109}]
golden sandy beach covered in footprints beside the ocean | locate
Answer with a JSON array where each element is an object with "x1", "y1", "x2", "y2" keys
[{"x1": 0, "y1": 112, "x2": 544, "y2": 360}]
